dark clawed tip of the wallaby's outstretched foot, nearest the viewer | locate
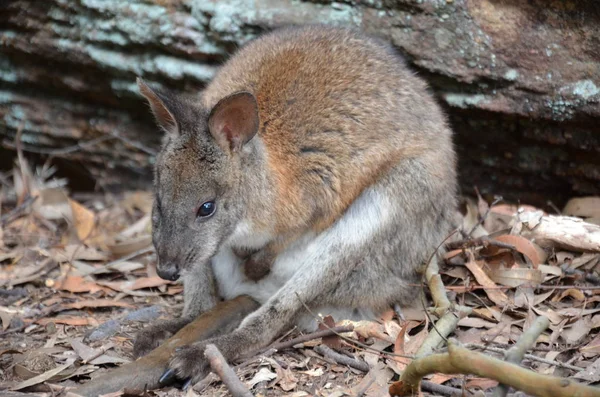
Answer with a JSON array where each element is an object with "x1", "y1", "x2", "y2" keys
[{"x1": 161, "y1": 341, "x2": 210, "y2": 388}]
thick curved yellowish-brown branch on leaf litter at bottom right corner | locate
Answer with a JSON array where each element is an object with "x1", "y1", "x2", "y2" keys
[{"x1": 389, "y1": 342, "x2": 600, "y2": 397}]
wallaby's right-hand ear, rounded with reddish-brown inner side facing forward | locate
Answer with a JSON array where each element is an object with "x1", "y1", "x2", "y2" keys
[{"x1": 208, "y1": 91, "x2": 258, "y2": 152}]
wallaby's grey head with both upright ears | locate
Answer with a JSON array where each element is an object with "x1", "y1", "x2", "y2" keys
[{"x1": 138, "y1": 79, "x2": 259, "y2": 280}]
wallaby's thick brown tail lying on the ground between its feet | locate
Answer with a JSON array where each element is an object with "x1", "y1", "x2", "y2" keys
[{"x1": 71, "y1": 296, "x2": 259, "y2": 397}]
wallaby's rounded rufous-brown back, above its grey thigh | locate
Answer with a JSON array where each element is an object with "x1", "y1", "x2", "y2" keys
[{"x1": 202, "y1": 27, "x2": 455, "y2": 237}]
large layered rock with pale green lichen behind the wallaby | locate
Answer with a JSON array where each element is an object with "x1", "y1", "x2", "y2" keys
[{"x1": 0, "y1": 0, "x2": 600, "y2": 206}]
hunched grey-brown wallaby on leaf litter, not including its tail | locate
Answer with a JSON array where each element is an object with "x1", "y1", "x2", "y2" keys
[{"x1": 72, "y1": 26, "x2": 457, "y2": 392}]
